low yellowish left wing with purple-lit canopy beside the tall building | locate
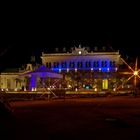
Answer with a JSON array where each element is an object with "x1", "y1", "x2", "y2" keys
[{"x1": 0, "y1": 64, "x2": 63, "y2": 91}]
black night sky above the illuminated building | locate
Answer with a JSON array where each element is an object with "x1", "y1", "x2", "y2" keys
[{"x1": 0, "y1": 6, "x2": 140, "y2": 70}]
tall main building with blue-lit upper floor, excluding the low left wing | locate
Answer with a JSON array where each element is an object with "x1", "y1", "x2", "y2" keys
[{"x1": 41, "y1": 45, "x2": 121, "y2": 90}]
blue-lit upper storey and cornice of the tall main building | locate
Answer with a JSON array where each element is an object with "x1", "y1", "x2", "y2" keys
[{"x1": 41, "y1": 47, "x2": 121, "y2": 71}]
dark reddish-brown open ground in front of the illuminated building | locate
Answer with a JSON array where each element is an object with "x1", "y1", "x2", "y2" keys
[{"x1": 3, "y1": 96, "x2": 140, "y2": 140}]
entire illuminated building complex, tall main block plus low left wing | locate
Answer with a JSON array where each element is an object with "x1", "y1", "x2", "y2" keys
[{"x1": 0, "y1": 45, "x2": 126, "y2": 91}]
